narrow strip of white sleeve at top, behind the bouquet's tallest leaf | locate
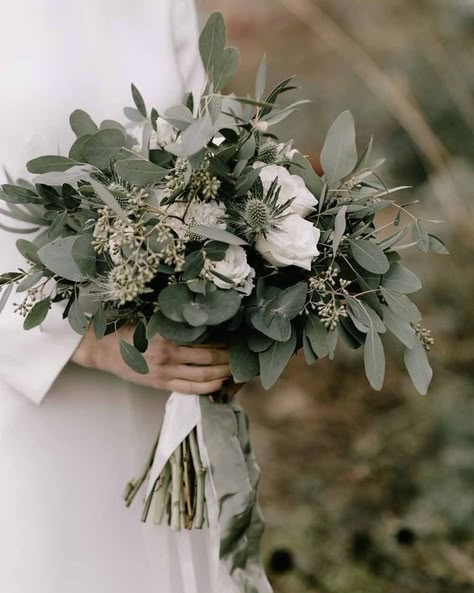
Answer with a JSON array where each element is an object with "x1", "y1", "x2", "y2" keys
[{"x1": 171, "y1": 0, "x2": 205, "y2": 100}]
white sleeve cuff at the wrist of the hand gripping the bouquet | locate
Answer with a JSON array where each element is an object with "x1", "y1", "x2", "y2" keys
[{"x1": 0, "y1": 221, "x2": 81, "y2": 404}]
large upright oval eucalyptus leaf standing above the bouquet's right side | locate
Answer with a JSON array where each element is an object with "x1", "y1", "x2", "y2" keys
[{"x1": 321, "y1": 111, "x2": 357, "y2": 186}]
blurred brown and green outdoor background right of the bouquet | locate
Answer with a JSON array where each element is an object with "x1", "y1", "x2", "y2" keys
[{"x1": 198, "y1": 0, "x2": 474, "y2": 593}]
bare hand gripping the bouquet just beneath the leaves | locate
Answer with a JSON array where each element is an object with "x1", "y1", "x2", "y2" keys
[{"x1": 71, "y1": 326, "x2": 231, "y2": 395}]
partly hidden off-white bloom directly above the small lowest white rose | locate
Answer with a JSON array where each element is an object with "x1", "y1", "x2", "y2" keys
[{"x1": 166, "y1": 200, "x2": 226, "y2": 239}]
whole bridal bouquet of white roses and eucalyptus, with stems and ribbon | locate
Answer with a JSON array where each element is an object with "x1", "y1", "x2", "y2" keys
[{"x1": 0, "y1": 13, "x2": 446, "y2": 593}]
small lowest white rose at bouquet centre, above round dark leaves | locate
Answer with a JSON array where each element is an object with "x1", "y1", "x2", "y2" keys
[{"x1": 203, "y1": 245, "x2": 255, "y2": 296}]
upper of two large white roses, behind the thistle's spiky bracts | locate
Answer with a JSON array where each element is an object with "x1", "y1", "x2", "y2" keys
[{"x1": 255, "y1": 163, "x2": 318, "y2": 217}]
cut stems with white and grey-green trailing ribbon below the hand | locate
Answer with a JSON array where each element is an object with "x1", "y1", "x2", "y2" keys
[{"x1": 124, "y1": 384, "x2": 272, "y2": 593}]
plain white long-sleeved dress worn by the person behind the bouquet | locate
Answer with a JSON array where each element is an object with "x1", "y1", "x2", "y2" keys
[{"x1": 0, "y1": 0, "x2": 213, "y2": 593}]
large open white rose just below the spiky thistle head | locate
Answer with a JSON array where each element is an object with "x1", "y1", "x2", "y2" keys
[{"x1": 255, "y1": 214, "x2": 321, "y2": 270}]
